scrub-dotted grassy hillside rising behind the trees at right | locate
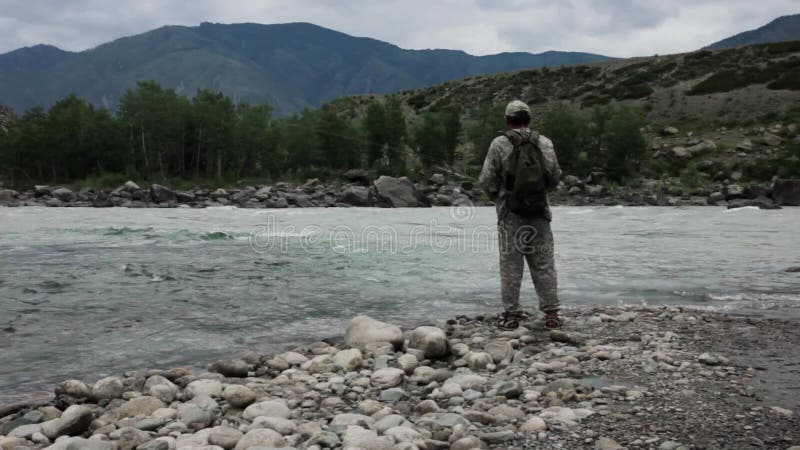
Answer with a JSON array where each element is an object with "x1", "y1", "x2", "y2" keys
[{"x1": 332, "y1": 41, "x2": 800, "y2": 185}]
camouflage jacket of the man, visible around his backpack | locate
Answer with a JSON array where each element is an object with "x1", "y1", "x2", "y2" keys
[{"x1": 480, "y1": 128, "x2": 561, "y2": 220}]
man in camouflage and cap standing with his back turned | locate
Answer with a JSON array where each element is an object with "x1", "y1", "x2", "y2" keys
[{"x1": 480, "y1": 100, "x2": 562, "y2": 329}]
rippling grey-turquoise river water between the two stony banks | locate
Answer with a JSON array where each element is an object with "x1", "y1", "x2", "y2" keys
[{"x1": 0, "y1": 207, "x2": 800, "y2": 403}]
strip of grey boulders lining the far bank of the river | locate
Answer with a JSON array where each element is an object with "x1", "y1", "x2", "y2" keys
[{"x1": 0, "y1": 170, "x2": 800, "y2": 209}]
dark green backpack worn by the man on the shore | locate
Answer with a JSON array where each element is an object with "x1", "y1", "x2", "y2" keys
[{"x1": 505, "y1": 131, "x2": 548, "y2": 217}]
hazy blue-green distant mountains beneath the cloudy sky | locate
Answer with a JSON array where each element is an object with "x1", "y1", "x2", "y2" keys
[{"x1": 0, "y1": 15, "x2": 800, "y2": 115}]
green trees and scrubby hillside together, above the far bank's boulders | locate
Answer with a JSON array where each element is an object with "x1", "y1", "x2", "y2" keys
[{"x1": 0, "y1": 42, "x2": 800, "y2": 190}]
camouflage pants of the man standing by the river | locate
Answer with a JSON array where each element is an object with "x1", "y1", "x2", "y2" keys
[{"x1": 498, "y1": 213, "x2": 560, "y2": 313}]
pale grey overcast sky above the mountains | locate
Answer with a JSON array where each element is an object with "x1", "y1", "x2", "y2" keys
[{"x1": 0, "y1": 0, "x2": 800, "y2": 57}]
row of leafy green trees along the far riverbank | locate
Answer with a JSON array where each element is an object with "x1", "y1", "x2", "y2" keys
[{"x1": 0, "y1": 81, "x2": 646, "y2": 187}]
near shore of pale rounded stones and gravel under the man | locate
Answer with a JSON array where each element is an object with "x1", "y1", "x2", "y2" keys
[{"x1": 0, "y1": 308, "x2": 800, "y2": 450}]
